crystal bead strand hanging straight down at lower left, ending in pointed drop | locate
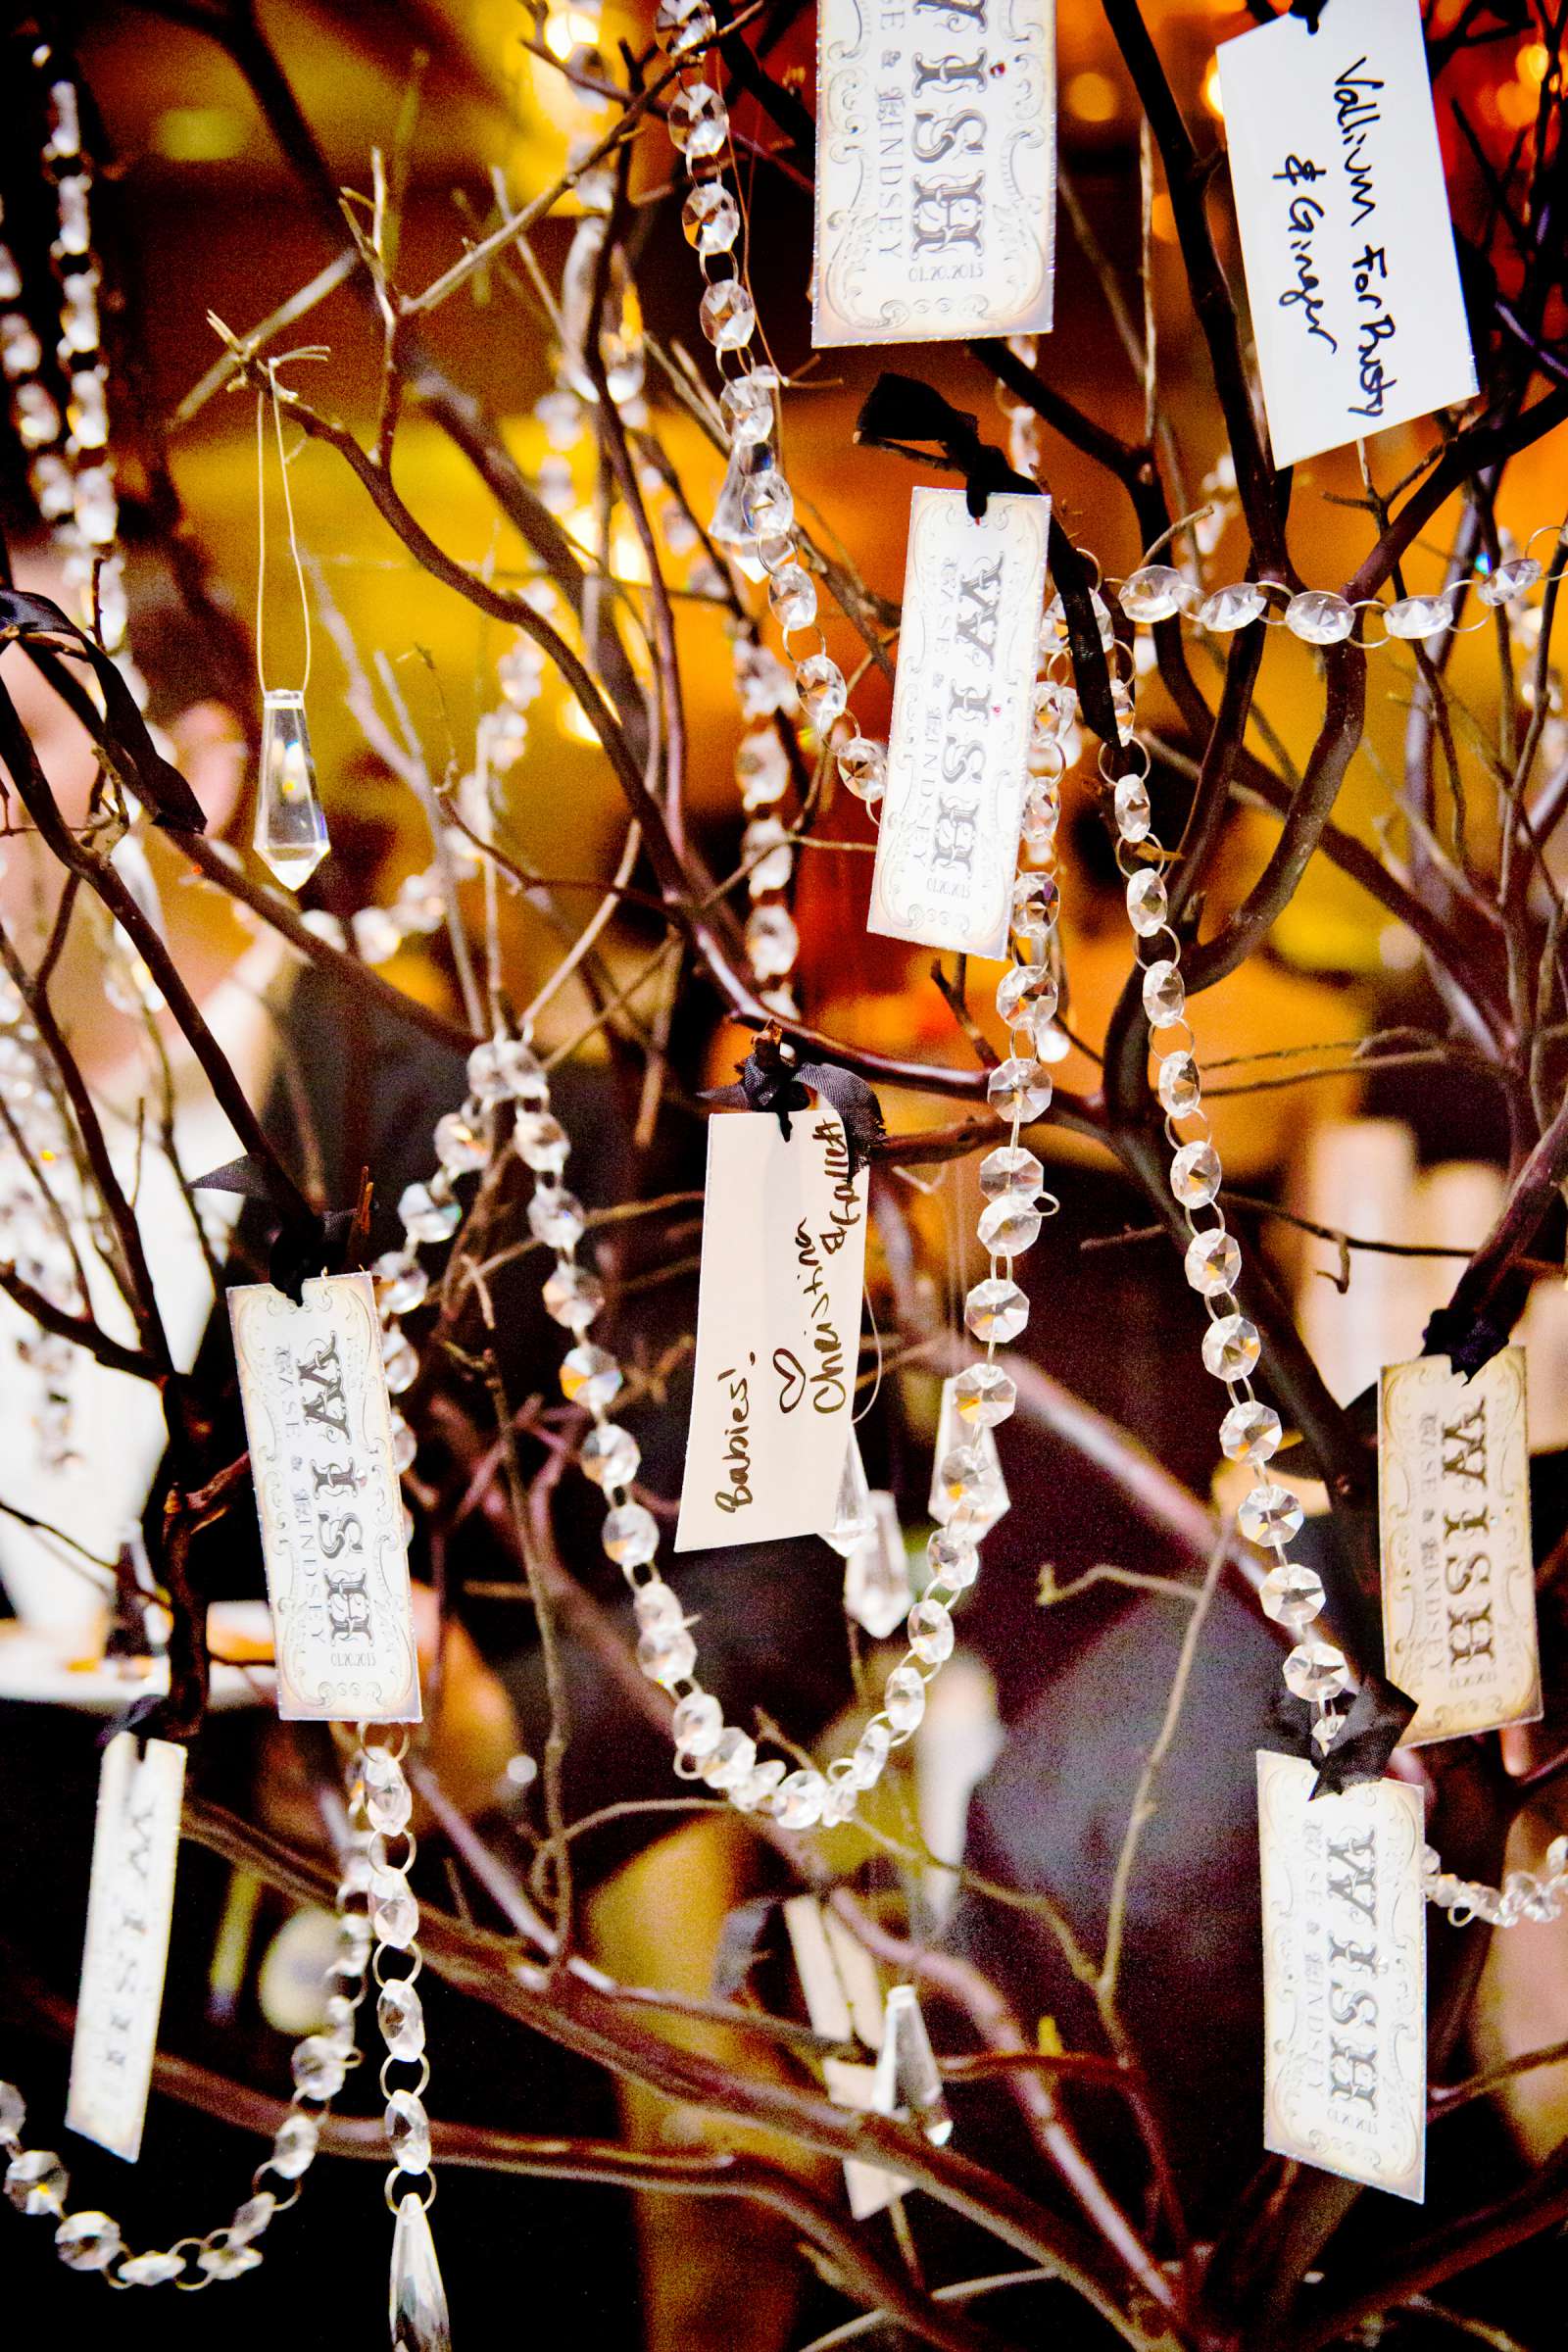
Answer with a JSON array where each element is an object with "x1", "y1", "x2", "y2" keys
[{"x1": 348, "y1": 1724, "x2": 452, "y2": 2352}]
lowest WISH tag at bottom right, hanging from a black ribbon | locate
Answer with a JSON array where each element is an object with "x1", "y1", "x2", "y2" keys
[{"x1": 1257, "y1": 1750, "x2": 1427, "y2": 2204}]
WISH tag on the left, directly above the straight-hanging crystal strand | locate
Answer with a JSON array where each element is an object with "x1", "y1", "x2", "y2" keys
[{"x1": 228, "y1": 1275, "x2": 418, "y2": 1724}]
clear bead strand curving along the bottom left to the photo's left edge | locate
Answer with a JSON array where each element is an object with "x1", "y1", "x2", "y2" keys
[{"x1": 0, "y1": 1796, "x2": 371, "y2": 2288}]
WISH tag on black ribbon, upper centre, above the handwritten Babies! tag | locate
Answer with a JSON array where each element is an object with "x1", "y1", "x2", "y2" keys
[{"x1": 867, "y1": 489, "x2": 1051, "y2": 955}]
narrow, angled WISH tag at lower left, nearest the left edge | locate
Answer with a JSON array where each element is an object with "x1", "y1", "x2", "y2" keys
[{"x1": 66, "y1": 1731, "x2": 186, "y2": 2164}]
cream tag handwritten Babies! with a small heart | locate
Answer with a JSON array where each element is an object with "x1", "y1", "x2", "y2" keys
[{"x1": 674, "y1": 1103, "x2": 870, "y2": 1552}]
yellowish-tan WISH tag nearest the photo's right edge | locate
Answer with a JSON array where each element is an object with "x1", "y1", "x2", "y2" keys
[{"x1": 1378, "y1": 1348, "x2": 1540, "y2": 1747}]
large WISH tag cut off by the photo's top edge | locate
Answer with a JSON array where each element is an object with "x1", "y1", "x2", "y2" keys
[{"x1": 811, "y1": 0, "x2": 1055, "y2": 346}]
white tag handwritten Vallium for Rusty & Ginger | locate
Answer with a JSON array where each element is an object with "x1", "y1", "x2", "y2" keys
[{"x1": 1220, "y1": 0, "x2": 1476, "y2": 466}]
